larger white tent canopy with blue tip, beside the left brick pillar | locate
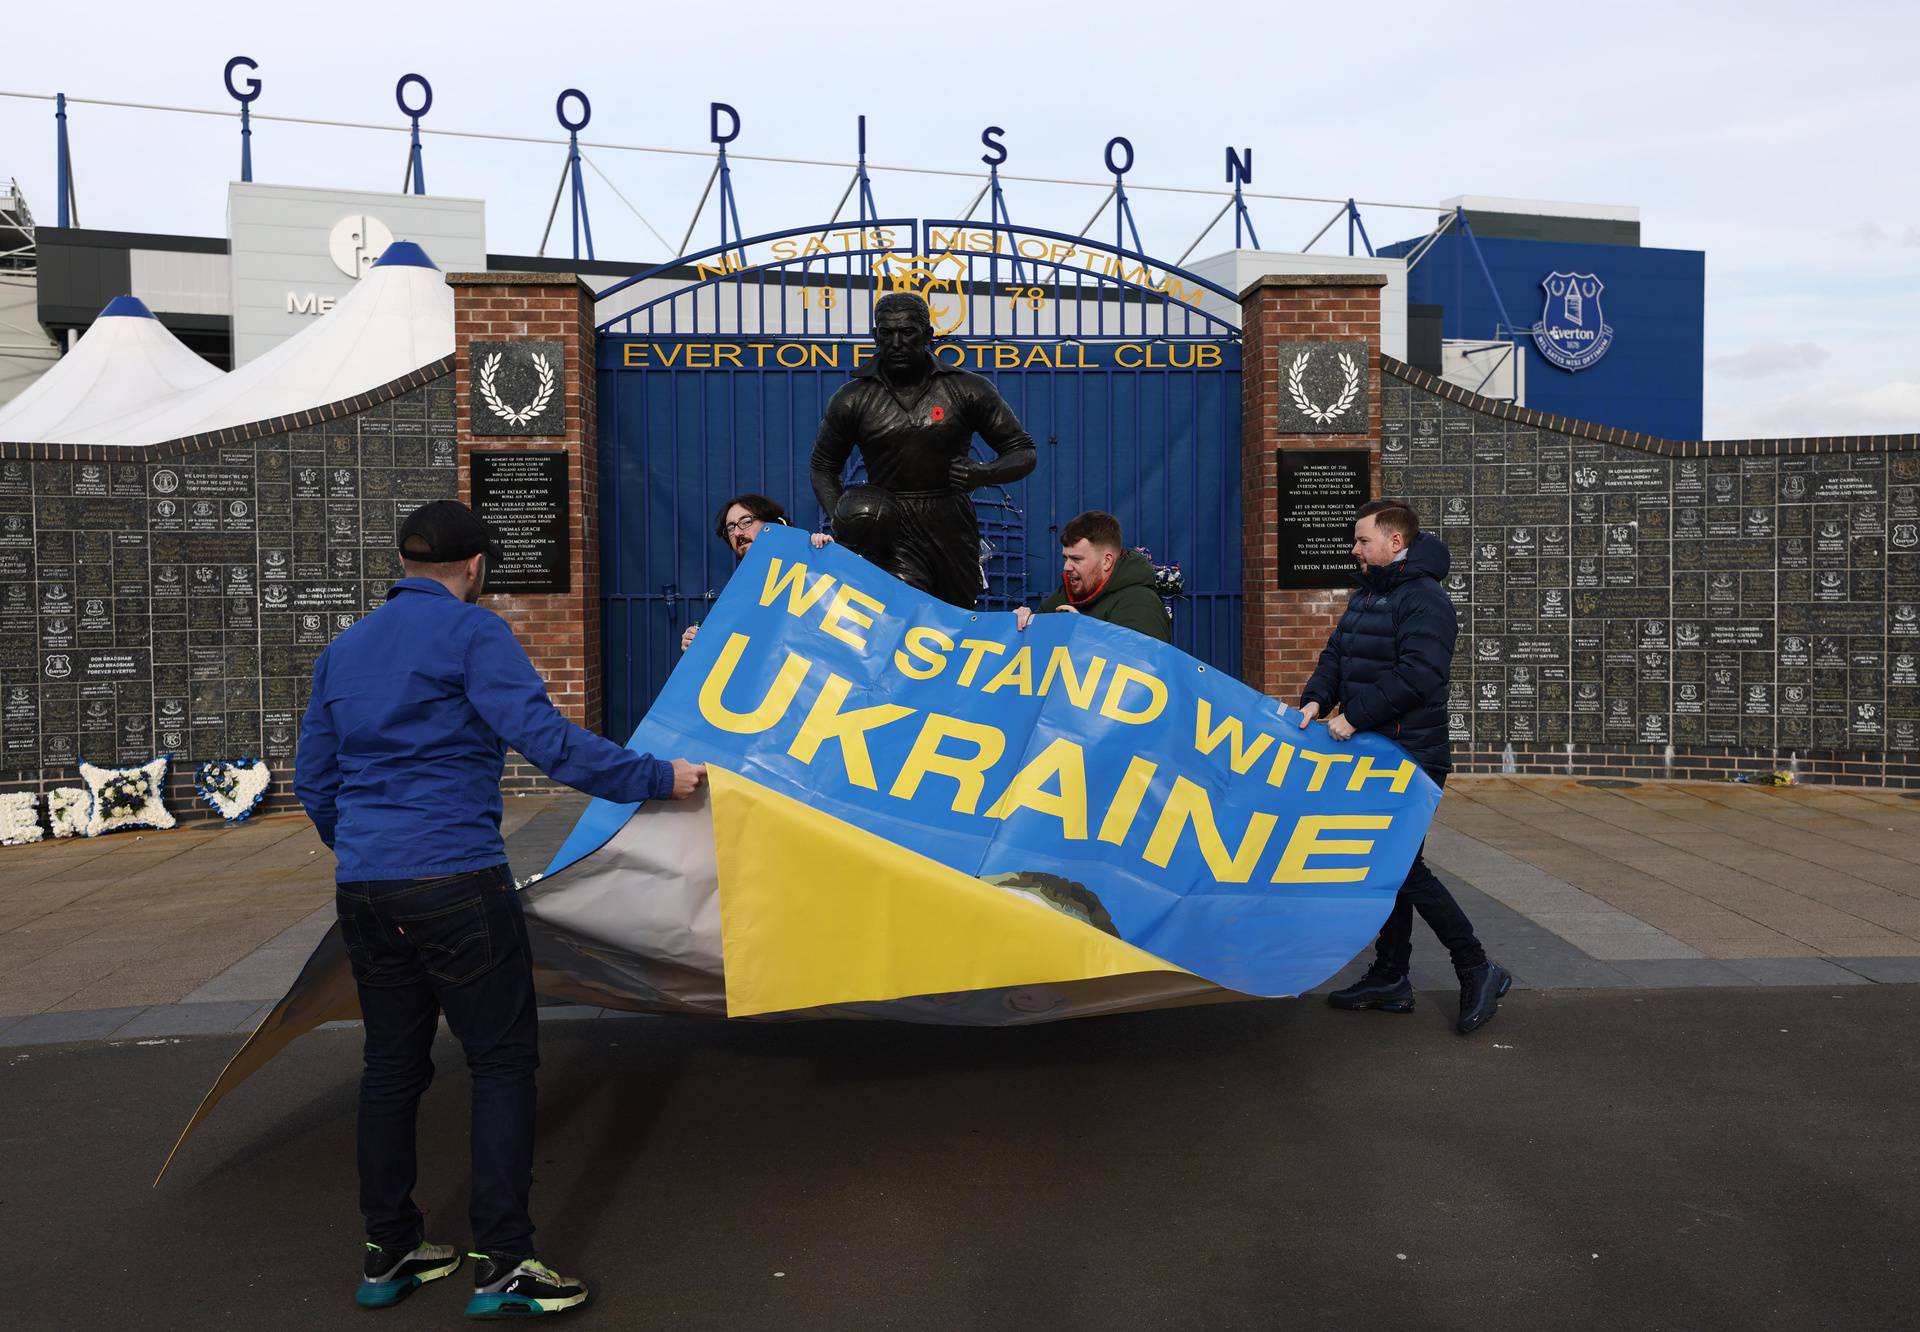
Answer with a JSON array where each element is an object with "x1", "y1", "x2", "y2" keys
[{"x1": 36, "y1": 240, "x2": 453, "y2": 456}]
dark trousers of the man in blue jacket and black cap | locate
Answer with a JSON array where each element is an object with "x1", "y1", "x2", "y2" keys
[{"x1": 334, "y1": 866, "x2": 540, "y2": 1257}]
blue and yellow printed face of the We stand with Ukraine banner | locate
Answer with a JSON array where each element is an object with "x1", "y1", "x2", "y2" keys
[{"x1": 530, "y1": 528, "x2": 1440, "y2": 1015}]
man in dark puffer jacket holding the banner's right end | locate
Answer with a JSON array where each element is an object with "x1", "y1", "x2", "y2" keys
[{"x1": 1300, "y1": 499, "x2": 1513, "y2": 1036}]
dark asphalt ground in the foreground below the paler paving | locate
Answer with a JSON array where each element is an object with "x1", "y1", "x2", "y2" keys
[{"x1": 0, "y1": 985, "x2": 1920, "y2": 1332}]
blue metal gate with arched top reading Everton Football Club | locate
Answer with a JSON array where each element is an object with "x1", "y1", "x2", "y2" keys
[{"x1": 597, "y1": 219, "x2": 1240, "y2": 737}]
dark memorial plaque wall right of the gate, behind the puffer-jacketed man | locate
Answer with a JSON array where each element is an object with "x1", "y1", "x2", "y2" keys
[{"x1": 1380, "y1": 361, "x2": 1920, "y2": 785}]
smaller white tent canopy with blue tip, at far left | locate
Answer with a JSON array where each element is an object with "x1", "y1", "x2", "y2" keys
[{"x1": 0, "y1": 296, "x2": 225, "y2": 443}]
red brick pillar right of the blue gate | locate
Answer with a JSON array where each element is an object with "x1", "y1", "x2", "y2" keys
[{"x1": 1240, "y1": 273, "x2": 1386, "y2": 702}]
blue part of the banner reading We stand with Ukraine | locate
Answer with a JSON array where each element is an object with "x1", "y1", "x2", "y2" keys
[{"x1": 549, "y1": 528, "x2": 1440, "y2": 994}]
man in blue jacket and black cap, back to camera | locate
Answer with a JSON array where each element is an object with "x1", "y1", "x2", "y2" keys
[{"x1": 294, "y1": 499, "x2": 707, "y2": 1317}]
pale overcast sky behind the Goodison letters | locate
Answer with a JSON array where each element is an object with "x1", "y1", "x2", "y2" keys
[{"x1": 0, "y1": 0, "x2": 1920, "y2": 438}]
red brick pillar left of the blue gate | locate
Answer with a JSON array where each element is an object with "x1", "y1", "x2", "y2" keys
[{"x1": 447, "y1": 273, "x2": 599, "y2": 789}]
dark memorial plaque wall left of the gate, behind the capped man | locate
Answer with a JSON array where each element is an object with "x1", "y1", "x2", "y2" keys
[{"x1": 0, "y1": 363, "x2": 459, "y2": 814}]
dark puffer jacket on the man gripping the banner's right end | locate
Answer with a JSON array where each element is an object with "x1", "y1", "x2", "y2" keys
[{"x1": 1300, "y1": 532, "x2": 1459, "y2": 772}]
